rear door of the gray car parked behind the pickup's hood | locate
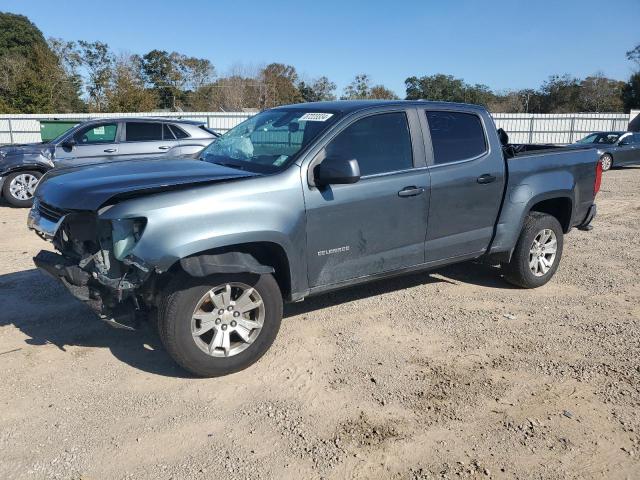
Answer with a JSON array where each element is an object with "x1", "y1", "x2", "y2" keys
[{"x1": 118, "y1": 120, "x2": 180, "y2": 160}]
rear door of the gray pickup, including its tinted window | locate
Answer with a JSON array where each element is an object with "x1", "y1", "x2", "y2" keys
[{"x1": 420, "y1": 109, "x2": 505, "y2": 262}]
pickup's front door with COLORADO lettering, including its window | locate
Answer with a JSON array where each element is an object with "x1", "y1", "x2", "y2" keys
[{"x1": 305, "y1": 111, "x2": 429, "y2": 287}]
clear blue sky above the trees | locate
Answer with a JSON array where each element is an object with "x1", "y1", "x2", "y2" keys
[{"x1": 0, "y1": 0, "x2": 640, "y2": 97}]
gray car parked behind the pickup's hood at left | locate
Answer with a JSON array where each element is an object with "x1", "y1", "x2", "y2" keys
[{"x1": 0, "y1": 117, "x2": 218, "y2": 207}]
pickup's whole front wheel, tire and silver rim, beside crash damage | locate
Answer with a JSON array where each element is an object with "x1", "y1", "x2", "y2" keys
[{"x1": 158, "y1": 273, "x2": 282, "y2": 377}]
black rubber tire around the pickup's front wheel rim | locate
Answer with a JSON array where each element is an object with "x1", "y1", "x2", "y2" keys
[{"x1": 158, "y1": 273, "x2": 282, "y2": 377}]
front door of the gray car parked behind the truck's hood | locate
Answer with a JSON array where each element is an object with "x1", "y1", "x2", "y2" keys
[{"x1": 55, "y1": 122, "x2": 120, "y2": 167}]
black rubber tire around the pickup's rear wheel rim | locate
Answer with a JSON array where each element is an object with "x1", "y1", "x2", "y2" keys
[{"x1": 502, "y1": 212, "x2": 563, "y2": 288}]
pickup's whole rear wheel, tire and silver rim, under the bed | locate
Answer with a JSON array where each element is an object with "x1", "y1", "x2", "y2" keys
[{"x1": 503, "y1": 212, "x2": 563, "y2": 288}]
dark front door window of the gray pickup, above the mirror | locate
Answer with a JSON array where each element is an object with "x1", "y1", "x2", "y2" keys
[{"x1": 325, "y1": 112, "x2": 413, "y2": 176}]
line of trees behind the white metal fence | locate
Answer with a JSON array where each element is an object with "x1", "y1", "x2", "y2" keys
[{"x1": 0, "y1": 12, "x2": 640, "y2": 113}]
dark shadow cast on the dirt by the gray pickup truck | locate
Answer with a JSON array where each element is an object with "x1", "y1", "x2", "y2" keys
[{"x1": 0, "y1": 264, "x2": 508, "y2": 378}]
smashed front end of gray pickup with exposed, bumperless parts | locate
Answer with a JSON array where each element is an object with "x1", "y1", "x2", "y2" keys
[{"x1": 28, "y1": 199, "x2": 153, "y2": 329}]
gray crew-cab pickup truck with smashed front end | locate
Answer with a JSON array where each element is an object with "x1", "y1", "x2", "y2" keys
[{"x1": 28, "y1": 101, "x2": 602, "y2": 376}]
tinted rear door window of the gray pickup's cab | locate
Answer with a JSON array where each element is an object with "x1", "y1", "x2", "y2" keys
[{"x1": 426, "y1": 112, "x2": 487, "y2": 165}]
